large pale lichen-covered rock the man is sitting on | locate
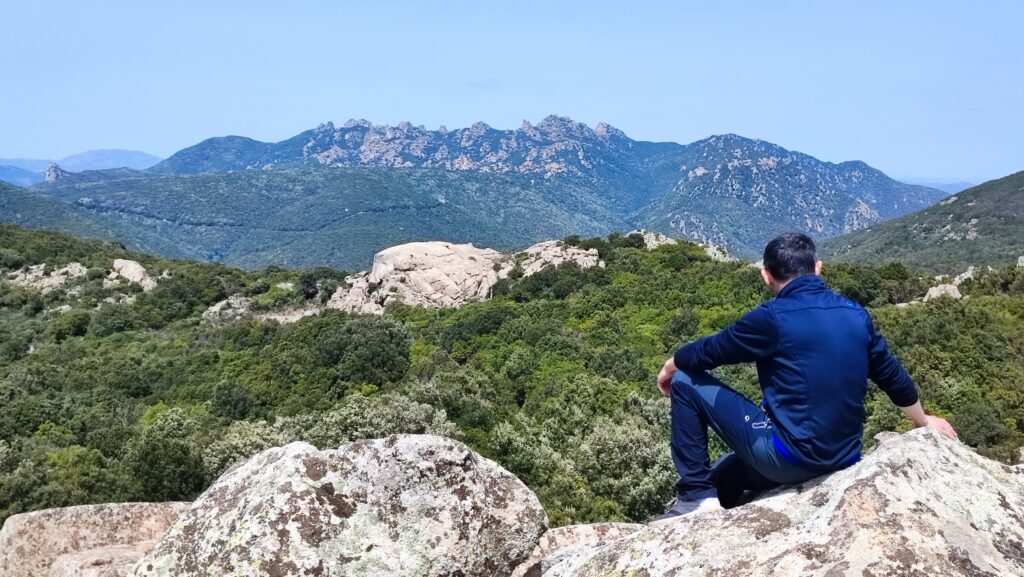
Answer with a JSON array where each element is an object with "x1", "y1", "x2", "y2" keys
[{"x1": 544, "y1": 429, "x2": 1024, "y2": 577}]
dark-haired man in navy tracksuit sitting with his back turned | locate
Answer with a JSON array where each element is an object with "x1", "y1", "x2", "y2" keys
[{"x1": 657, "y1": 233, "x2": 956, "y2": 520}]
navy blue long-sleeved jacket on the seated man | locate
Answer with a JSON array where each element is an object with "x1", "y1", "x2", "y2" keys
[{"x1": 675, "y1": 275, "x2": 918, "y2": 470}]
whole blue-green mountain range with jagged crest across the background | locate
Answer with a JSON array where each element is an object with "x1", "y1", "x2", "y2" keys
[{"x1": 5, "y1": 116, "x2": 945, "y2": 269}]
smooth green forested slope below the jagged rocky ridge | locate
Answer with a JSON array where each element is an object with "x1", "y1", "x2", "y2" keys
[{"x1": 29, "y1": 167, "x2": 630, "y2": 270}]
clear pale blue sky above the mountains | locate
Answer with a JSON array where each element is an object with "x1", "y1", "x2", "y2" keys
[{"x1": 0, "y1": 0, "x2": 1024, "y2": 182}]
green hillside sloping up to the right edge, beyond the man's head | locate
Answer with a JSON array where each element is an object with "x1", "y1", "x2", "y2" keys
[{"x1": 822, "y1": 172, "x2": 1024, "y2": 273}]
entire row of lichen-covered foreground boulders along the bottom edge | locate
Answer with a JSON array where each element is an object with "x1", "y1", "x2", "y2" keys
[{"x1": 0, "y1": 429, "x2": 1024, "y2": 577}]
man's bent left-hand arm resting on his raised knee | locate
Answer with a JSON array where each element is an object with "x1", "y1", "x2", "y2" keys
[{"x1": 657, "y1": 305, "x2": 778, "y2": 396}]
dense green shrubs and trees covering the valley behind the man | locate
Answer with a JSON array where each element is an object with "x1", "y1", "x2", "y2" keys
[{"x1": 0, "y1": 225, "x2": 1024, "y2": 525}]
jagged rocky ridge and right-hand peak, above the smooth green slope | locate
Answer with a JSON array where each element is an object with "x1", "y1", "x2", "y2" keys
[{"x1": 140, "y1": 116, "x2": 945, "y2": 256}]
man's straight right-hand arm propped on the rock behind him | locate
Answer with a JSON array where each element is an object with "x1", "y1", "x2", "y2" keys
[{"x1": 867, "y1": 317, "x2": 956, "y2": 439}]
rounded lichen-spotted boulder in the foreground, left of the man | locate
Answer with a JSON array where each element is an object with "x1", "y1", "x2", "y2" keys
[{"x1": 132, "y1": 435, "x2": 547, "y2": 577}]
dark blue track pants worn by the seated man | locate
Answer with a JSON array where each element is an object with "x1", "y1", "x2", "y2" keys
[{"x1": 671, "y1": 371, "x2": 820, "y2": 506}]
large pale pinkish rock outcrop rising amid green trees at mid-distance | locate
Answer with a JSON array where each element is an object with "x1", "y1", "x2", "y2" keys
[{"x1": 328, "y1": 241, "x2": 604, "y2": 315}]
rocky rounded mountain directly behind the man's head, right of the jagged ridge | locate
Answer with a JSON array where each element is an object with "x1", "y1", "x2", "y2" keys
[{"x1": 633, "y1": 134, "x2": 945, "y2": 256}]
